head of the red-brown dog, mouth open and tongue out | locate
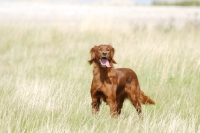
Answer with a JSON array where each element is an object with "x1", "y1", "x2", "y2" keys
[{"x1": 88, "y1": 44, "x2": 116, "y2": 67}]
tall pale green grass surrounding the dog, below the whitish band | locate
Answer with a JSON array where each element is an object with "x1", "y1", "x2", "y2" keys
[{"x1": 0, "y1": 24, "x2": 200, "y2": 133}]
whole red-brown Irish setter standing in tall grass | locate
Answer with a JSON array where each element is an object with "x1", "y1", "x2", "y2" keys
[{"x1": 88, "y1": 44, "x2": 155, "y2": 117}]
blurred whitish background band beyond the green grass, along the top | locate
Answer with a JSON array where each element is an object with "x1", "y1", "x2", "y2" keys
[{"x1": 0, "y1": 0, "x2": 200, "y2": 27}]
